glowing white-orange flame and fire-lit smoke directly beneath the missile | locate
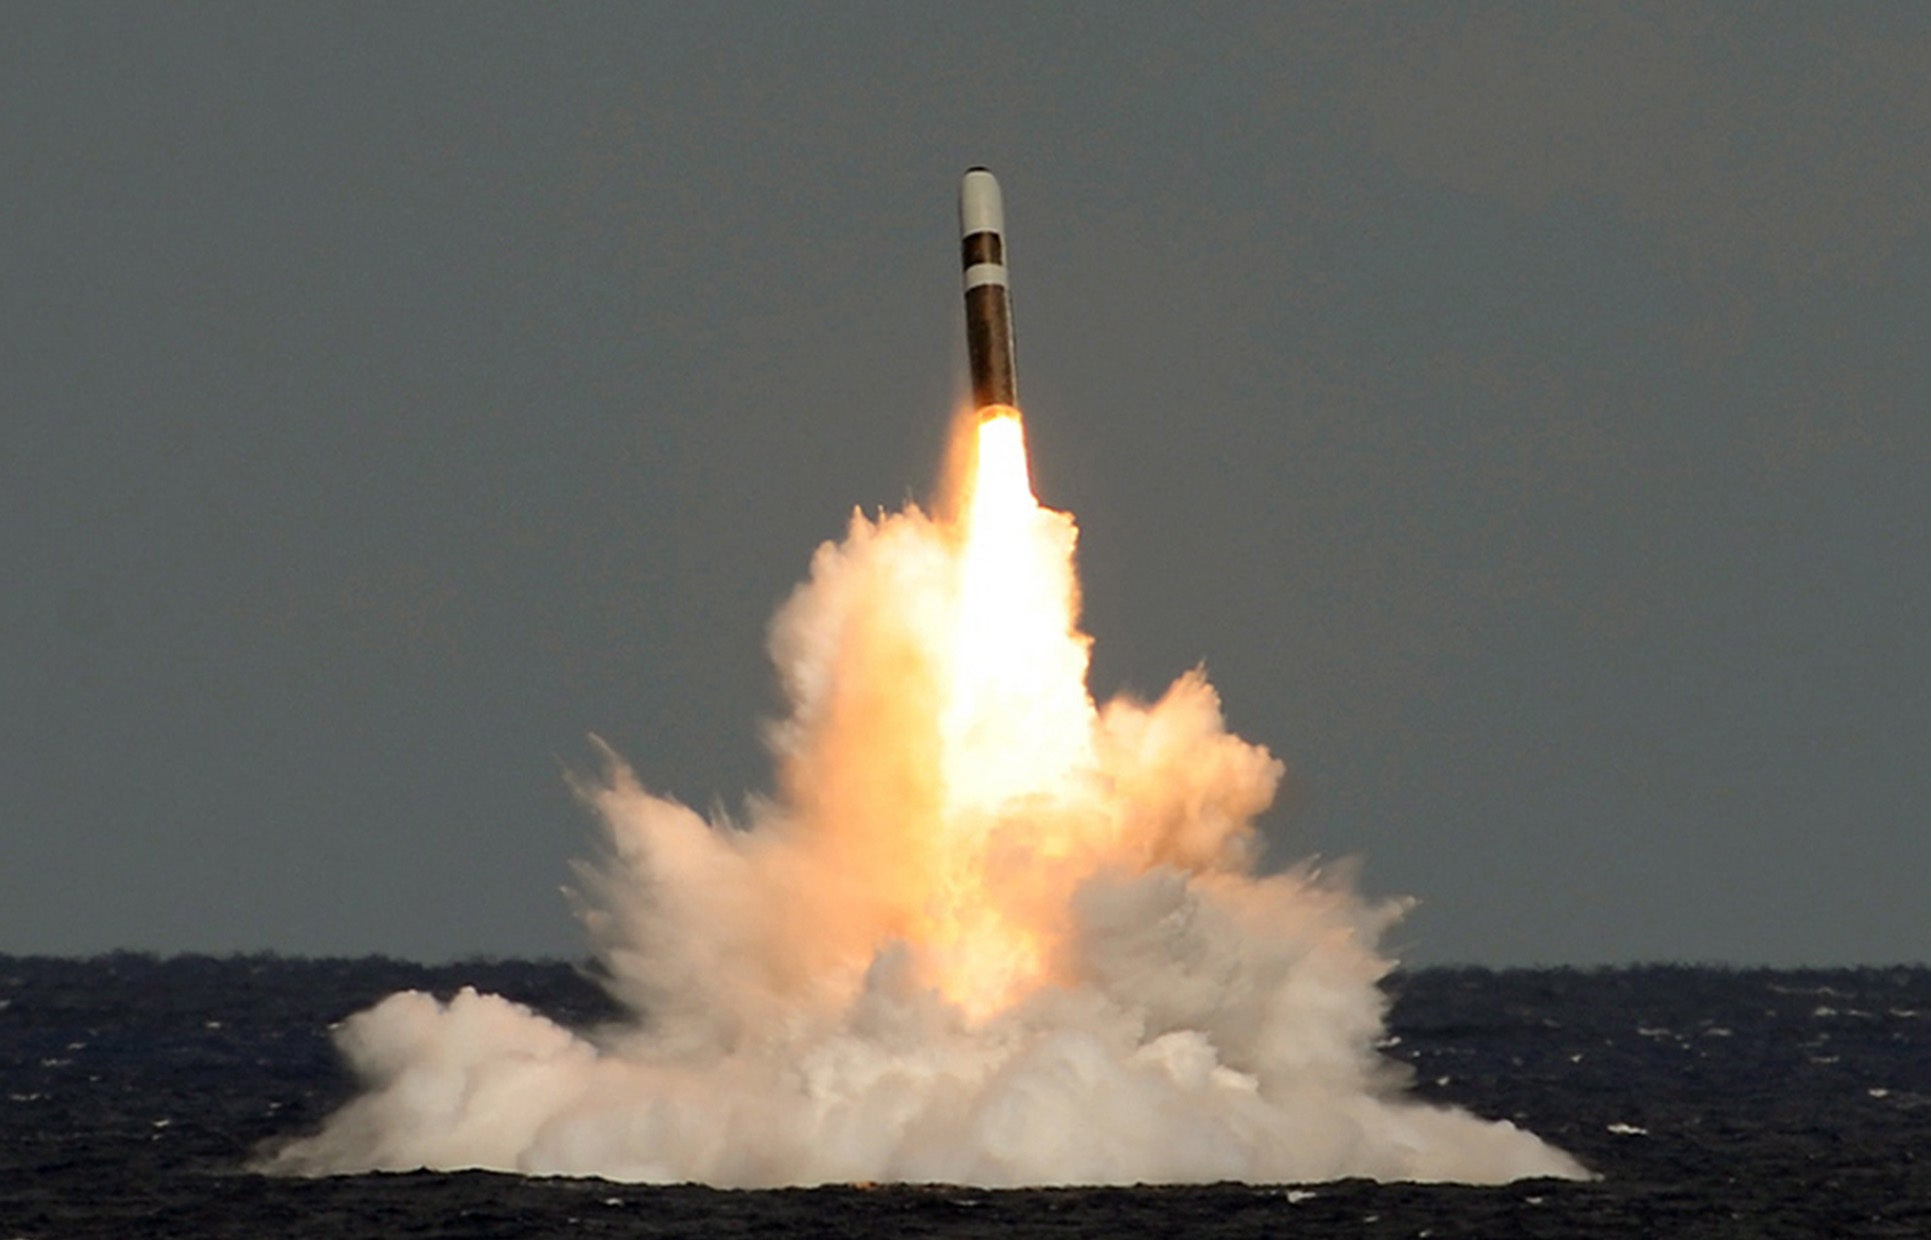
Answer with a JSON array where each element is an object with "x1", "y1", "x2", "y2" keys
[{"x1": 756, "y1": 408, "x2": 1280, "y2": 1020}]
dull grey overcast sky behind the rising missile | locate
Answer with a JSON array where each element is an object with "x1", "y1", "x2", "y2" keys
[{"x1": 0, "y1": 4, "x2": 1931, "y2": 964}]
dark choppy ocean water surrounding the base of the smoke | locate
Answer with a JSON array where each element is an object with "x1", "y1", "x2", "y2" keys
[{"x1": 0, "y1": 954, "x2": 1931, "y2": 1240}]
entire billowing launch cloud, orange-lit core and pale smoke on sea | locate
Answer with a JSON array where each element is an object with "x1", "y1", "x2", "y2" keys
[{"x1": 263, "y1": 423, "x2": 1583, "y2": 1186}]
